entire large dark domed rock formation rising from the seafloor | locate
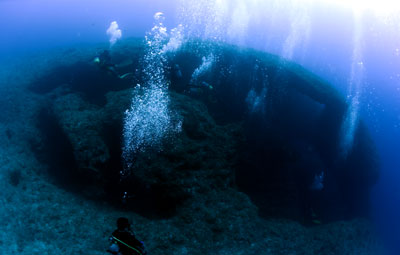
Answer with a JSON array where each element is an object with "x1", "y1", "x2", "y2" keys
[{"x1": 32, "y1": 37, "x2": 378, "y2": 221}]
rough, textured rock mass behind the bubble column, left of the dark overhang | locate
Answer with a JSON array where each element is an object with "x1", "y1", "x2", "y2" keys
[{"x1": 35, "y1": 84, "x2": 241, "y2": 213}]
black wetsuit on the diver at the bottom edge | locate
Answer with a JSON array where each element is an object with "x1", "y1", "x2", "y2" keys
[{"x1": 112, "y1": 229, "x2": 146, "y2": 255}]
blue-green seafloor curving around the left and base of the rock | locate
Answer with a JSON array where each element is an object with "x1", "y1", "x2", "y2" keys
[{"x1": 0, "y1": 40, "x2": 378, "y2": 255}]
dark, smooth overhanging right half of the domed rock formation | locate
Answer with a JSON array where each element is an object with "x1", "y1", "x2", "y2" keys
[{"x1": 171, "y1": 42, "x2": 379, "y2": 221}]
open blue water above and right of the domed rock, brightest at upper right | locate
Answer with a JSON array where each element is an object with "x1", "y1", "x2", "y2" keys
[{"x1": 0, "y1": 0, "x2": 400, "y2": 254}]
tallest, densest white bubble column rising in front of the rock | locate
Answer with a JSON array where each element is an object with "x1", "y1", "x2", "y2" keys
[{"x1": 122, "y1": 13, "x2": 182, "y2": 170}]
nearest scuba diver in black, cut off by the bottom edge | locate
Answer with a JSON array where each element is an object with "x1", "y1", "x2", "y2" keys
[{"x1": 107, "y1": 217, "x2": 147, "y2": 255}]
